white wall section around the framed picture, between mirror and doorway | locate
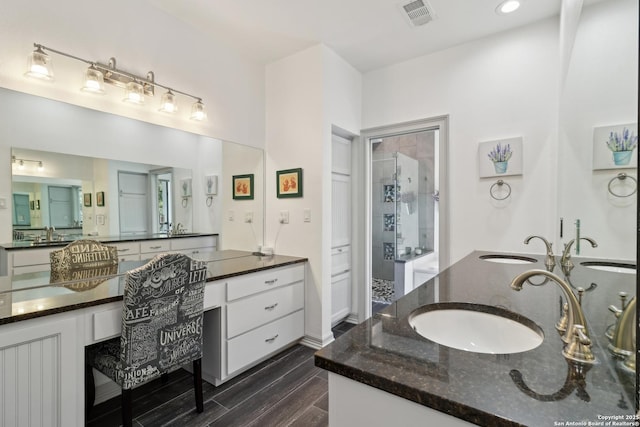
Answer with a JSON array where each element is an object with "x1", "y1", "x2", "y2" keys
[{"x1": 265, "y1": 45, "x2": 361, "y2": 345}]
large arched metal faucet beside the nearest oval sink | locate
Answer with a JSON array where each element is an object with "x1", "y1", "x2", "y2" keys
[{"x1": 511, "y1": 270, "x2": 596, "y2": 364}]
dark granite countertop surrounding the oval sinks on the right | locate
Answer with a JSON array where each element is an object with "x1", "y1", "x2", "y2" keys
[{"x1": 315, "y1": 251, "x2": 637, "y2": 427}]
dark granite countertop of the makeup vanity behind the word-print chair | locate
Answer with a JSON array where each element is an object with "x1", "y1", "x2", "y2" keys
[{"x1": 0, "y1": 250, "x2": 307, "y2": 325}]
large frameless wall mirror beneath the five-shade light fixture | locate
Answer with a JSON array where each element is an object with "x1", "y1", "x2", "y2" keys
[{"x1": 0, "y1": 88, "x2": 264, "y2": 250}]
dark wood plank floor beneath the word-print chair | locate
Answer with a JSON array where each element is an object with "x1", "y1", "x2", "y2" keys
[{"x1": 87, "y1": 323, "x2": 353, "y2": 427}]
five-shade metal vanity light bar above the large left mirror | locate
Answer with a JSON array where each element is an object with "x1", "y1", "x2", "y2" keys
[{"x1": 25, "y1": 43, "x2": 207, "y2": 121}]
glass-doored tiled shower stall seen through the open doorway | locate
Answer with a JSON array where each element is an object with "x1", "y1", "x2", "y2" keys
[{"x1": 371, "y1": 131, "x2": 437, "y2": 303}]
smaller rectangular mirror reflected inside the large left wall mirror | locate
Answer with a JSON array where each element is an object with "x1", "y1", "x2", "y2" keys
[{"x1": 11, "y1": 148, "x2": 192, "y2": 240}]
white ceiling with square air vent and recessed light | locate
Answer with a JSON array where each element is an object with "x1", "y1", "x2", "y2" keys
[{"x1": 148, "y1": 0, "x2": 561, "y2": 72}]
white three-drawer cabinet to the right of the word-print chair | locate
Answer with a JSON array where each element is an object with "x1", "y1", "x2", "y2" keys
[{"x1": 202, "y1": 264, "x2": 305, "y2": 385}]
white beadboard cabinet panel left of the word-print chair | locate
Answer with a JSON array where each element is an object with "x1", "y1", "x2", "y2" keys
[{"x1": 0, "y1": 312, "x2": 84, "y2": 427}]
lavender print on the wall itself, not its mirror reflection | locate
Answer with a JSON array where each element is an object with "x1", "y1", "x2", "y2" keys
[{"x1": 478, "y1": 137, "x2": 522, "y2": 178}]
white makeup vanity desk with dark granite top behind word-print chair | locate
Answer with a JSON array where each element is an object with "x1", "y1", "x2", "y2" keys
[{"x1": 0, "y1": 250, "x2": 307, "y2": 426}]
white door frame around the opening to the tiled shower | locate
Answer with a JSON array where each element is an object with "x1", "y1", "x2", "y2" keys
[{"x1": 354, "y1": 115, "x2": 451, "y2": 322}]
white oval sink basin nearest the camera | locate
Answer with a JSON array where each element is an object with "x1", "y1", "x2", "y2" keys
[{"x1": 409, "y1": 302, "x2": 544, "y2": 354}]
